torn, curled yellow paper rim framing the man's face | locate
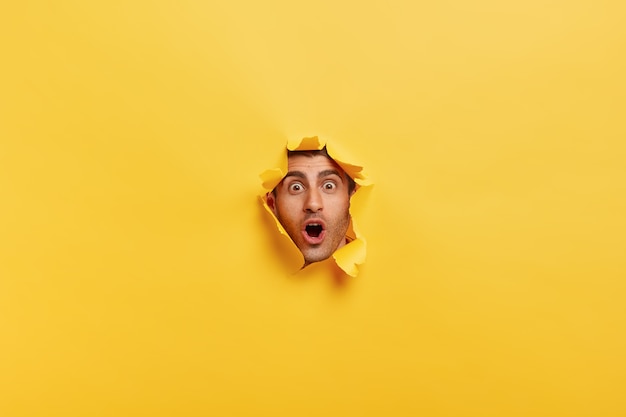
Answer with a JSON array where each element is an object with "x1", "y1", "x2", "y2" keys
[{"x1": 260, "y1": 136, "x2": 372, "y2": 277}]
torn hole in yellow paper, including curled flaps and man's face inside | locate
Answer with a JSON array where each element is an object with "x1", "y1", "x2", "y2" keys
[{"x1": 260, "y1": 136, "x2": 371, "y2": 277}]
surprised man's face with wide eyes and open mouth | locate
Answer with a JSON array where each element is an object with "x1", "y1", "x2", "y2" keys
[{"x1": 267, "y1": 155, "x2": 351, "y2": 265}]
